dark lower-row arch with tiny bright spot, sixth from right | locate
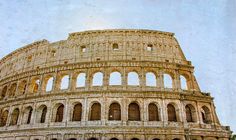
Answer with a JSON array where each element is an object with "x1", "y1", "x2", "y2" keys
[{"x1": 108, "y1": 103, "x2": 121, "y2": 120}]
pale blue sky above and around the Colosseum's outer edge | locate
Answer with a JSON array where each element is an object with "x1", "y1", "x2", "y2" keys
[{"x1": 0, "y1": 0, "x2": 236, "y2": 132}]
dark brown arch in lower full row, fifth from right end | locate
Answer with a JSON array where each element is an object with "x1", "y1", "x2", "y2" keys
[{"x1": 128, "y1": 103, "x2": 141, "y2": 121}]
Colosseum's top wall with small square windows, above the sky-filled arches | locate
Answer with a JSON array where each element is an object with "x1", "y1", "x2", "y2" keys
[{"x1": 0, "y1": 30, "x2": 192, "y2": 80}]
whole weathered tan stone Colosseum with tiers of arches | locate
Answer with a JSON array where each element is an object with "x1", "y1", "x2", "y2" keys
[{"x1": 0, "y1": 29, "x2": 232, "y2": 140}]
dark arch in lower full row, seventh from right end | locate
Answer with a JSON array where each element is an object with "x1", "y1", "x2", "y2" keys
[{"x1": 89, "y1": 103, "x2": 101, "y2": 121}]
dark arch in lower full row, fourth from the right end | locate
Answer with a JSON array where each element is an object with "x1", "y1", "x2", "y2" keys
[{"x1": 148, "y1": 103, "x2": 159, "y2": 121}]
